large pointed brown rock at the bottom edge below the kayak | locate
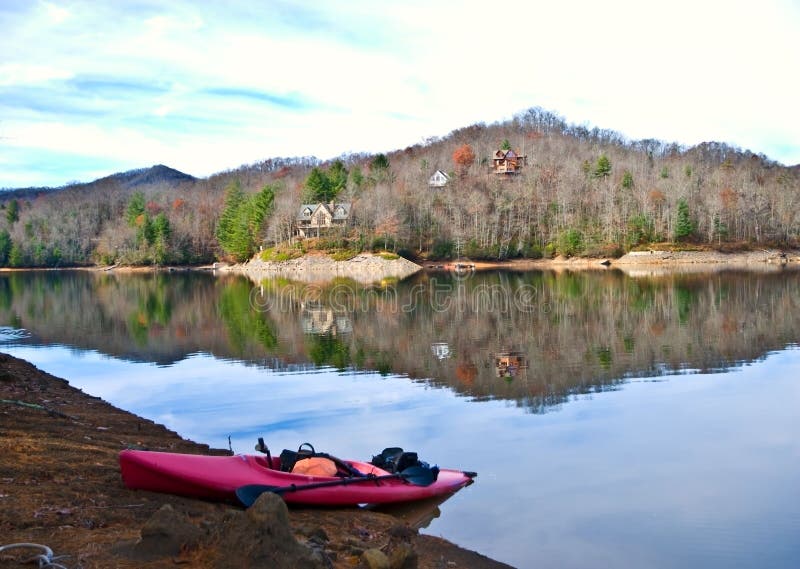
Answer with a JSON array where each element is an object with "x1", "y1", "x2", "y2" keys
[{"x1": 214, "y1": 492, "x2": 330, "y2": 569}]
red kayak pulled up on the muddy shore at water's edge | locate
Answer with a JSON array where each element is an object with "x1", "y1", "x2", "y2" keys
[{"x1": 119, "y1": 450, "x2": 474, "y2": 506}]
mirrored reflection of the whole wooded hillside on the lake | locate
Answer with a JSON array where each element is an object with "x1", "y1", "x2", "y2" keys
[{"x1": 0, "y1": 271, "x2": 800, "y2": 411}]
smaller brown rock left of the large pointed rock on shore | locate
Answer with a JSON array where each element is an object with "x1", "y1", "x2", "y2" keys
[{"x1": 130, "y1": 504, "x2": 203, "y2": 560}]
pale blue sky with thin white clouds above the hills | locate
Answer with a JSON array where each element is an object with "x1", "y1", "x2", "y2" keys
[{"x1": 0, "y1": 0, "x2": 800, "y2": 188}]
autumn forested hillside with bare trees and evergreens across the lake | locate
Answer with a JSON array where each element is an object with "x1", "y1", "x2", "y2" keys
[{"x1": 0, "y1": 108, "x2": 800, "y2": 266}]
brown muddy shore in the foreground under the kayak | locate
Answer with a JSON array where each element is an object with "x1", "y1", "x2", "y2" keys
[{"x1": 0, "y1": 354, "x2": 508, "y2": 569}]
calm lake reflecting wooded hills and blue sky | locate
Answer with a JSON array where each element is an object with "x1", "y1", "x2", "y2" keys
[{"x1": 0, "y1": 269, "x2": 800, "y2": 568}]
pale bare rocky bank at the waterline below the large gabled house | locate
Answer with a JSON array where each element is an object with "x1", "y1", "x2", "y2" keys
[{"x1": 220, "y1": 253, "x2": 422, "y2": 284}]
